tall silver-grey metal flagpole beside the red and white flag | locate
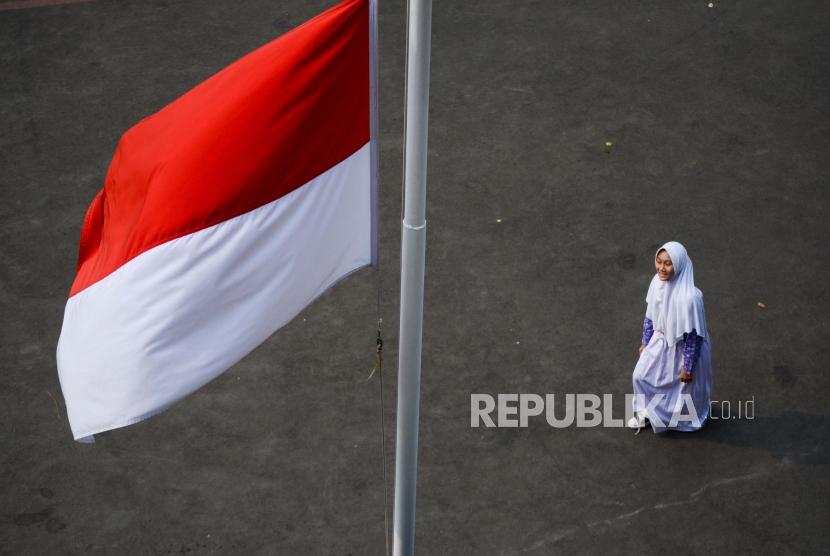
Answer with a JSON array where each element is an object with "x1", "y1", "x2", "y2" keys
[{"x1": 394, "y1": 0, "x2": 432, "y2": 556}]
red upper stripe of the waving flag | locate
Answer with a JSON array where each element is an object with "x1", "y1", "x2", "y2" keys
[{"x1": 70, "y1": 0, "x2": 370, "y2": 296}]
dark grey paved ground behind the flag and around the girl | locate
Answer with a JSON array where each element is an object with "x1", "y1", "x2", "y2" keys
[{"x1": 0, "y1": 0, "x2": 830, "y2": 555}]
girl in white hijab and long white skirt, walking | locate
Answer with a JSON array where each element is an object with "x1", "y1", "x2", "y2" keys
[{"x1": 628, "y1": 241, "x2": 712, "y2": 432}]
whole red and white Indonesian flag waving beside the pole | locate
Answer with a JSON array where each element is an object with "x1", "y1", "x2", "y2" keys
[{"x1": 57, "y1": 0, "x2": 377, "y2": 441}]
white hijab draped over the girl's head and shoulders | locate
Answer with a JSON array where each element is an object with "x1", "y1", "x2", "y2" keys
[{"x1": 646, "y1": 241, "x2": 709, "y2": 344}]
